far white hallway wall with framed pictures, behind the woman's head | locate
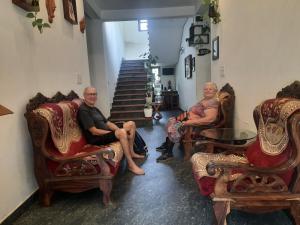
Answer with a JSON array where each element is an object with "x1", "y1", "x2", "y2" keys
[{"x1": 176, "y1": 18, "x2": 211, "y2": 110}]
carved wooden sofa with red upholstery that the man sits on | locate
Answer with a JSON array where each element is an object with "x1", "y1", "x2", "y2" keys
[{"x1": 25, "y1": 91, "x2": 123, "y2": 206}]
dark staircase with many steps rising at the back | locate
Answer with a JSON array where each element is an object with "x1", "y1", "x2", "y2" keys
[{"x1": 110, "y1": 60, "x2": 152, "y2": 127}]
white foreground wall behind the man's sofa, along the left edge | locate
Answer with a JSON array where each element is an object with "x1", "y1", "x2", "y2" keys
[{"x1": 0, "y1": 1, "x2": 90, "y2": 223}]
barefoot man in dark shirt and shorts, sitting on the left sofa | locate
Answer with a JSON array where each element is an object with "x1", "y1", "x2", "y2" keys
[{"x1": 78, "y1": 87, "x2": 145, "y2": 175}]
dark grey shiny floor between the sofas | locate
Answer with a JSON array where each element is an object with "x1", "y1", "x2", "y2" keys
[{"x1": 13, "y1": 112, "x2": 292, "y2": 225}]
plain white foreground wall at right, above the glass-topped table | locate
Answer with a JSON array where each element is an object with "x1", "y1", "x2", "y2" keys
[{"x1": 211, "y1": 0, "x2": 300, "y2": 130}]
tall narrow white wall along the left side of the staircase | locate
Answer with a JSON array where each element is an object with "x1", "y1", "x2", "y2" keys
[{"x1": 87, "y1": 19, "x2": 124, "y2": 116}]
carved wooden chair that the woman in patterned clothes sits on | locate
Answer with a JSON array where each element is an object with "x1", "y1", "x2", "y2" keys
[{"x1": 182, "y1": 83, "x2": 235, "y2": 160}]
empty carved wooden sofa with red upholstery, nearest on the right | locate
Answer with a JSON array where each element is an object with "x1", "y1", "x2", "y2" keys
[{"x1": 191, "y1": 81, "x2": 300, "y2": 225}]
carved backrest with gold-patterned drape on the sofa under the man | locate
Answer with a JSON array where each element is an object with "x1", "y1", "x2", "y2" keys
[{"x1": 25, "y1": 92, "x2": 86, "y2": 157}]
